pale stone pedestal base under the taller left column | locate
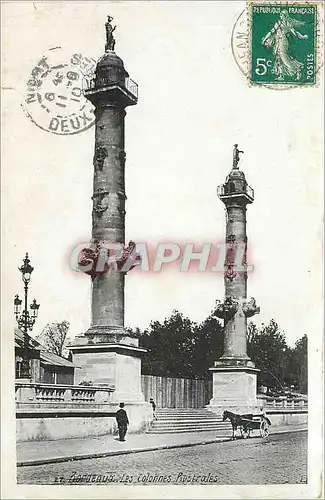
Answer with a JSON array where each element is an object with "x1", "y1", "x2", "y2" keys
[{"x1": 69, "y1": 336, "x2": 152, "y2": 433}]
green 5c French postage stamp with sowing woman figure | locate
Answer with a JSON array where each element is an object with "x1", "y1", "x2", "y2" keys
[{"x1": 249, "y1": 2, "x2": 317, "y2": 86}]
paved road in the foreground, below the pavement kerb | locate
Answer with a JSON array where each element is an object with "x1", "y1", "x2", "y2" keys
[{"x1": 18, "y1": 432, "x2": 307, "y2": 486}]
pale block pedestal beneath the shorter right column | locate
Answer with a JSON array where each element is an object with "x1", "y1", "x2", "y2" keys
[{"x1": 207, "y1": 366, "x2": 259, "y2": 414}]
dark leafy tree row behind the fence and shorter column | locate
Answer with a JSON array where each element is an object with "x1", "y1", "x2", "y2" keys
[{"x1": 130, "y1": 310, "x2": 307, "y2": 386}]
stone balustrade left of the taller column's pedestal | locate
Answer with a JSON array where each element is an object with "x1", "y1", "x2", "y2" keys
[{"x1": 15, "y1": 380, "x2": 114, "y2": 404}]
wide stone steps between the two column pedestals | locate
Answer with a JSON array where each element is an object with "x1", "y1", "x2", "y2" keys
[{"x1": 148, "y1": 408, "x2": 232, "y2": 435}]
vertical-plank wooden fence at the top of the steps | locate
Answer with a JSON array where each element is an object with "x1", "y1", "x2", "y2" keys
[{"x1": 141, "y1": 375, "x2": 212, "y2": 408}]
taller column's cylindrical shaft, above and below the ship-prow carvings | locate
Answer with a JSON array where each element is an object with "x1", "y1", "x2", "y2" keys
[{"x1": 92, "y1": 103, "x2": 126, "y2": 327}]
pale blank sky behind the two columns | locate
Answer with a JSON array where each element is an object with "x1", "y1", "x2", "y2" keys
[{"x1": 2, "y1": 1, "x2": 323, "y2": 345}]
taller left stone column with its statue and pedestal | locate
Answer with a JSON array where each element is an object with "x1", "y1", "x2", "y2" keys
[{"x1": 70, "y1": 17, "x2": 150, "y2": 430}]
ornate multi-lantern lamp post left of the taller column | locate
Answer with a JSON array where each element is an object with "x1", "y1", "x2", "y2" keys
[{"x1": 14, "y1": 253, "x2": 40, "y2": 378}]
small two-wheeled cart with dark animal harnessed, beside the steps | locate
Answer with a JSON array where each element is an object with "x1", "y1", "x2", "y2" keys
[{"x1": 222, "y1": 410, "x2": 271, "y2": 439}]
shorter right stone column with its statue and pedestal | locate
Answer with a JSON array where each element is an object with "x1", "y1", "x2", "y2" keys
[{"x1": 209, "y1": 144, "x2": 259, "y2": 413}]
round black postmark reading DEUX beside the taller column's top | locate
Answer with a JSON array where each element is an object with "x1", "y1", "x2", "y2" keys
[{"x1": 22, "y1": 47, "x2": 96, "y2": 135}]
